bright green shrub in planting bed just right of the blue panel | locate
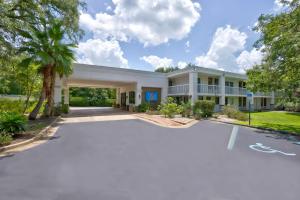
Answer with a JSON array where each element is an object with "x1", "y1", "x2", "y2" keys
[{"x1": 158, "y1": 97, "x2": 182, "y2": 118}]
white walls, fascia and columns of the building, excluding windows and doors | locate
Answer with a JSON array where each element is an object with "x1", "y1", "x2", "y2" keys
[{"x1": 54, "y1": 64, "x2": 274, "y2": 109}]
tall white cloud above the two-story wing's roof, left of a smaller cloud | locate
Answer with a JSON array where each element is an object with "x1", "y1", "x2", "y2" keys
[{"x1": 195, "y1": 25, "x2": 247, "y2": 72}]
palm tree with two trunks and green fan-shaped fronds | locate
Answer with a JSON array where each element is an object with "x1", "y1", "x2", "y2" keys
[{"x1": 20, "y1": 20, "x2": 76, "y2": 120}]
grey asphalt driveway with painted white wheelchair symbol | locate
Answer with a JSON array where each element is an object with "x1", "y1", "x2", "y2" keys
[{"x1": 0, "y1": 119, "x2": 300, "y2": 200}]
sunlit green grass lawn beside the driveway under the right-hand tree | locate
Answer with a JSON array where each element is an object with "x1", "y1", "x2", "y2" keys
[{"x1": 238, "y1": 111, "x2": 300, "y2": 135}]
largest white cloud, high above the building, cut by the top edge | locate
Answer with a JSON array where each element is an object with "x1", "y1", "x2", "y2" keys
[{"x1": 80, "y1": 0, "x2": 201, "y2": 46}]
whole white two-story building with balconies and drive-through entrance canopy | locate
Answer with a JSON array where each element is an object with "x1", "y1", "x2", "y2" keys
[{"x1": 54, "y1": 63, "x2": 275, "y2": 111}]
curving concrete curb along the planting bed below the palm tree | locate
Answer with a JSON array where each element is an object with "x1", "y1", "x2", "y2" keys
[{"x1": 0, "y1": 117, "x2": 60, "y2": 153}]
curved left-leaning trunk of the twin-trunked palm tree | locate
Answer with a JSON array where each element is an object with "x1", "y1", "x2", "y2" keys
[{"x1": 28, "y1": 65, "x2": 51, "y2": 120}]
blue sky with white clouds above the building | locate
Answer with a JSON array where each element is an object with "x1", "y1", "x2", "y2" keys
[{"x1": 76, "y1": 0, "x2": 283, "y2": 73}]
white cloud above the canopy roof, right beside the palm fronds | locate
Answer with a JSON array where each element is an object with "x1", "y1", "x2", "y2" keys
[{"x1": 76, "y1": 39, "x2": 128, "y2": 68}]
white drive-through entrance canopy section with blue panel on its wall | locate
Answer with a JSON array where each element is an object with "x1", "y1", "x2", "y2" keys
[{"x1": 54, "y1": 64, "x2": 167, "y2": 113}]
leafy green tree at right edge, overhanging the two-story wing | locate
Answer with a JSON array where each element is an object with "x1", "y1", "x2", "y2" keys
[{"x1": 247, "y1": 0, "x2": 300, "y2": 101}]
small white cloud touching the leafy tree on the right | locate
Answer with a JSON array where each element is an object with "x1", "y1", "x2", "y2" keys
[{"x1": 236, "y1": 49, "x2": 263, "y2": 71}]
